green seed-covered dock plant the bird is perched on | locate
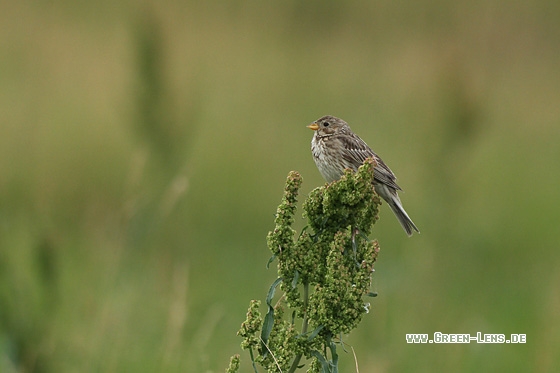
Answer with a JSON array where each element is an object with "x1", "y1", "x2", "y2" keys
[{"x1": 228, "y1": 159, "x2": 381, "y2": 373}]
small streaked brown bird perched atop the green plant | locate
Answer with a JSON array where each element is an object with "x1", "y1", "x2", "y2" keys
[{"x1": 307, "y1": 115, "x2": 420, "y2": 236}]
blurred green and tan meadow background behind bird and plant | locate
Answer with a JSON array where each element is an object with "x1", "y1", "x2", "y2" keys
[{"x1": 0, "y1": 0, "x2": 560, "y2": 372}]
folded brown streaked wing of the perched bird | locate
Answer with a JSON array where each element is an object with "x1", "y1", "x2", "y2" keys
[{"x1": 340, "y1": 134, "x2": 402, "y2": 190}]
